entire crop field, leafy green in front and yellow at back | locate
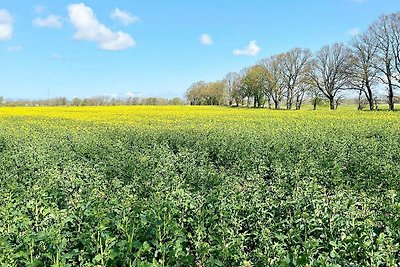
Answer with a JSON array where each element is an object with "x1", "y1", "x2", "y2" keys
[{"x1": 0, "y1": 106, "x2": 400, "y2": 266}]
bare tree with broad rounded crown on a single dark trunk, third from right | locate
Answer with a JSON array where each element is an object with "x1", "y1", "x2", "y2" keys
[{"x1": 310, "y1": 43, "x2": 351, "y2": 109}]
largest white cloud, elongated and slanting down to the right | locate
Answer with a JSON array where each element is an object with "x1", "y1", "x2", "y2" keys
[{"x1": 68, "y1": 3, "x2": 135, "y2": 50}]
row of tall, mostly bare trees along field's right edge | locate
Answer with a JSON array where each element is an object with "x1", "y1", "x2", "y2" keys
[{"x1": 186, "y1": 12, "x2": 400, "y2": 110}]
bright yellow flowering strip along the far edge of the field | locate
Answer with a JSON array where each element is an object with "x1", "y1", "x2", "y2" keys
[{"x1": 0, "y1": 106, "x2": 400, "y2": 129}]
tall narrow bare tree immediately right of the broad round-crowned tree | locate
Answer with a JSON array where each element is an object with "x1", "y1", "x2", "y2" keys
[{"x1": 350, "y1": 33, "x2": 378, "y2": 110}]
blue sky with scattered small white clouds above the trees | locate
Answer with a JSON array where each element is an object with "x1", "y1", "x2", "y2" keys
[{"x1": 0, "y1": 0, "x2": 400, "y2": 99}]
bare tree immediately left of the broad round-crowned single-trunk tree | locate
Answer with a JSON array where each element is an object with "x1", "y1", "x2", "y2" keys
[{"x1": 282, "y1": 48, "x2": 312, "y2": 109}]
